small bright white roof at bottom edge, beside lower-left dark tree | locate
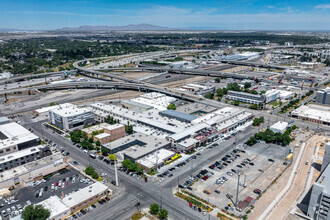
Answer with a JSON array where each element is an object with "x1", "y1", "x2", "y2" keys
[{"x1": 37, "y1": 195, "x2": 70, "y2": 219}]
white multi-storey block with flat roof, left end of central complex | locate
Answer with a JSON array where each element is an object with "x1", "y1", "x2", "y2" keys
[{"x1": 49, "y1": 105, "x2": 94, "y2": 130}]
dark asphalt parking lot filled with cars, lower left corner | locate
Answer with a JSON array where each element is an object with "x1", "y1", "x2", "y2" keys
[{"x1": 0, "y1": 169, "x2": 92, "y2": 219}]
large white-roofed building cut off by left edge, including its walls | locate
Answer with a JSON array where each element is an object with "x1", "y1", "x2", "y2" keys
[{"x1": 0, "y1": 122, "x2": 40, "y2": 156}]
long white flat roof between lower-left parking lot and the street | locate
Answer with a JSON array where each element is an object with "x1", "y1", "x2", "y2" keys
[{"x1": 62, "y1": 182, "x2": 108, "y2": 208}]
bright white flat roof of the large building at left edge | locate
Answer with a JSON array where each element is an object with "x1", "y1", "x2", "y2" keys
[{"x1": 0, "y1": 122, "x2": 39, "y2": 148}]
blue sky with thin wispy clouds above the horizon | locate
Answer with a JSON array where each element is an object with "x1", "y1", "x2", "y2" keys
[{"x1": 0, "y1": 0, "x2": 330, "y2": 30}]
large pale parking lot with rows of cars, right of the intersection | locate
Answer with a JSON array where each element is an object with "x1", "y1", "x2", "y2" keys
[{"x1": 180, "y1": 143, "x2": 289, "y2": 213}]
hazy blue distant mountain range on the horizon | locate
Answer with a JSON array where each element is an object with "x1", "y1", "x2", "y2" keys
[{"x1": 55, "y1": 23, "x2": 173, "y2": 31}]
